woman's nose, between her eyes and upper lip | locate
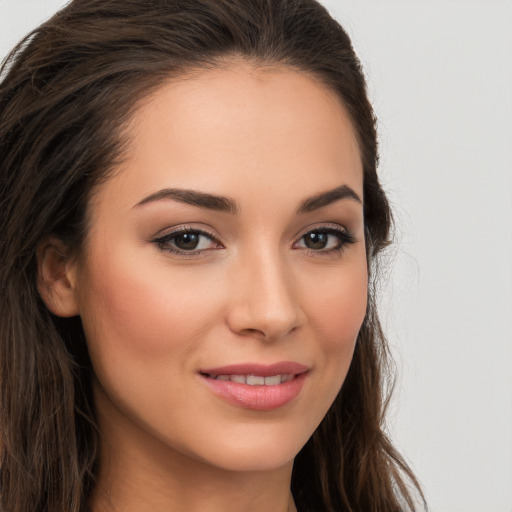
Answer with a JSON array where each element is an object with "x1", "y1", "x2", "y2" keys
[{"x1": 227, "y1": 253, "x2": 305, "y2": 341}]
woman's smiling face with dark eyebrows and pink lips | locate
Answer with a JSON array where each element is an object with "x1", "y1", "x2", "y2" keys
[{"x1": 76, "y1": 64, "x2": 367, "y2": 471}]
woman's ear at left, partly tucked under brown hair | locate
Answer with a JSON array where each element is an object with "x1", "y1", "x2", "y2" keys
[{"x1": 37, "y1": 236, "x2": 78, "y2": 317}]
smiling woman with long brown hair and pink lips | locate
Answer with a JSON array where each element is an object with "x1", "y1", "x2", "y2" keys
[{"x1": 0, "y1": 0, "x2": 421, "y2": 512}]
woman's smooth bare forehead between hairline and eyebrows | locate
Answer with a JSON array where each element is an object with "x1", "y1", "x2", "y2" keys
[{"x1": 90, "y1": 63, "x2": 362, "y2": 214}]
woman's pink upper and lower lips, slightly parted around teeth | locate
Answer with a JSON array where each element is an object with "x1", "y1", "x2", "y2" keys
[{"x1": 199, "y1": 361, "x2": 309, "y2": 411}]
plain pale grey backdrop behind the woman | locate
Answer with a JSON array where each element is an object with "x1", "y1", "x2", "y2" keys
[{"x1": 0, "y1": 0, "x2": 512, "y2": 512}]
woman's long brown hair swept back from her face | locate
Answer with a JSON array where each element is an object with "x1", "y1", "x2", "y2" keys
[{"x1": 0, "y1": 0, "x2": 424, "y2": 512}]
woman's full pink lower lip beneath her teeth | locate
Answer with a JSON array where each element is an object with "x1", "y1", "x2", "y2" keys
[{"x1": 201, "y1": 372, "x2": 307, "y2": 411}]
